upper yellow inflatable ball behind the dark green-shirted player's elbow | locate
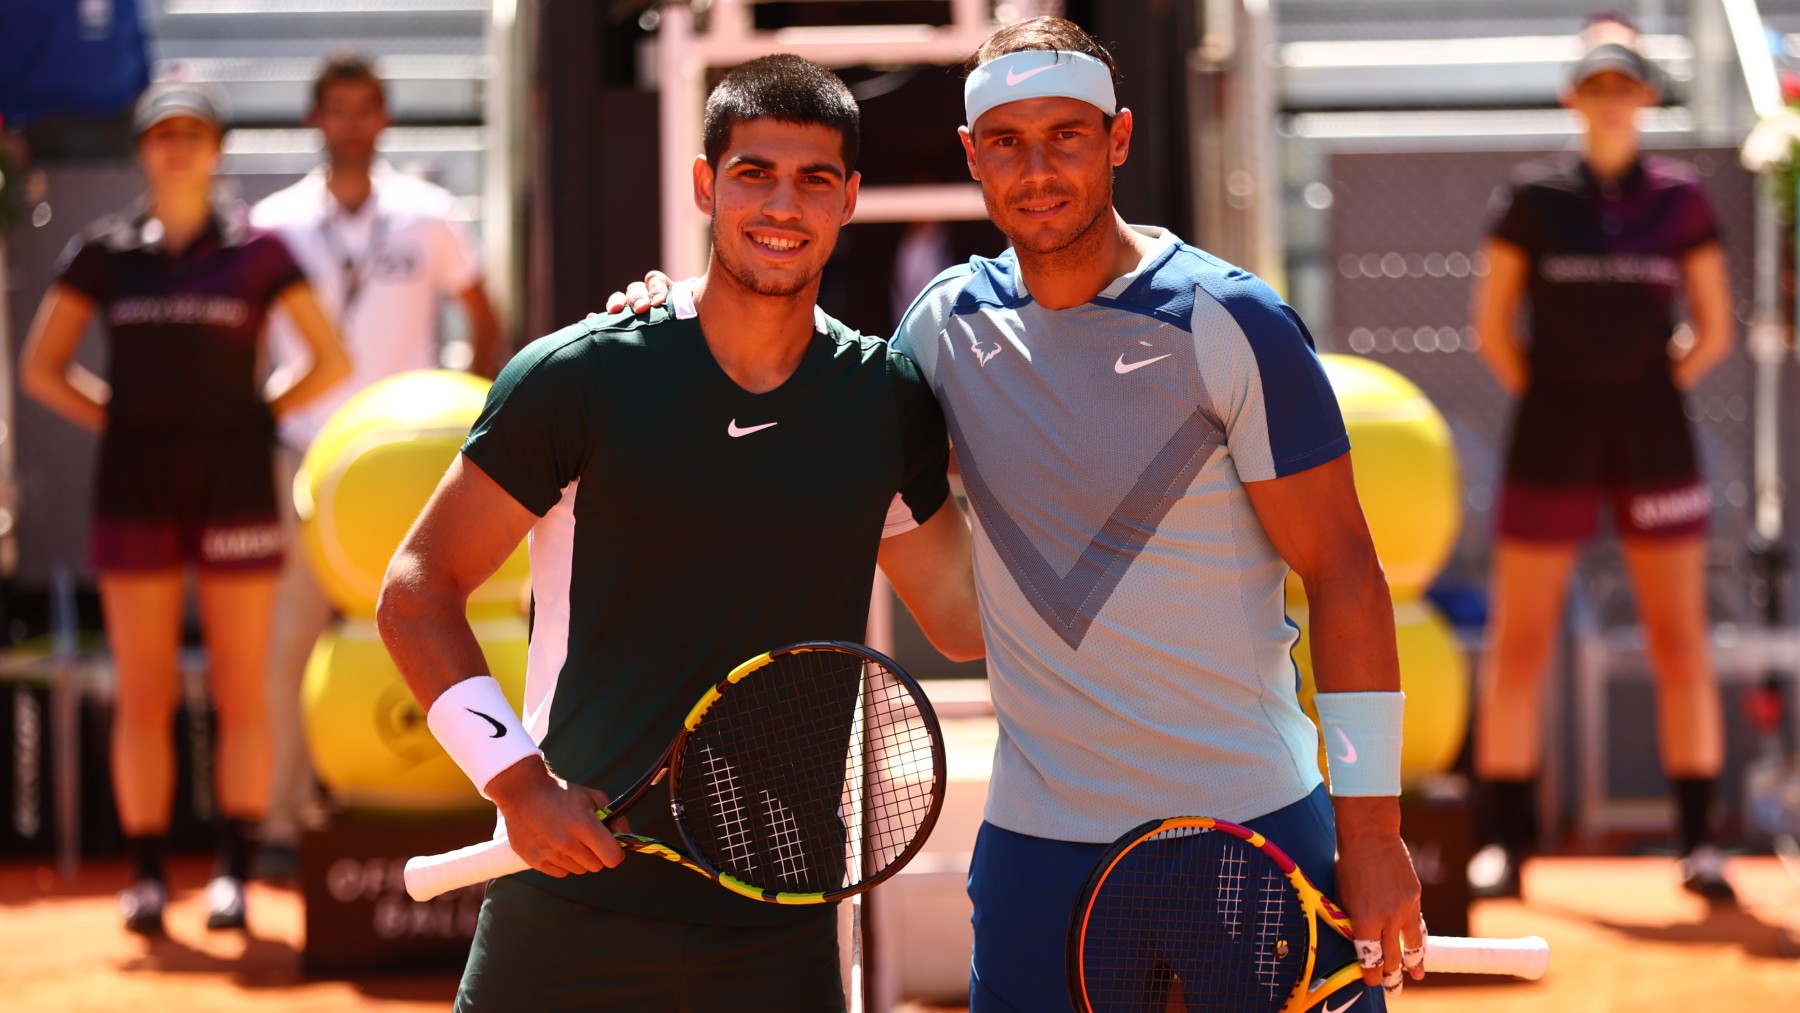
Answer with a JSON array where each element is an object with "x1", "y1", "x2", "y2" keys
[{"x1": 293, "y1": 369, "x2": 531, "y2": 619}]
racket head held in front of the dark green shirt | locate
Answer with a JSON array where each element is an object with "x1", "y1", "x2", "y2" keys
[{"x1": 668, "y1": 641, "x2": 947, "y2": 903}]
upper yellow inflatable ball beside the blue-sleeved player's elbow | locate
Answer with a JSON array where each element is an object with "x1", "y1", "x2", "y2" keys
[{"x1": 1287, "y1": 354, "x2": 1462, "y2": 601}]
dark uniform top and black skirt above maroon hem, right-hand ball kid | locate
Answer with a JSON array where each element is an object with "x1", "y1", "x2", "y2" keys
[{"x1": 1490, "y1": 155, "x2": 1719, "y2": 503}]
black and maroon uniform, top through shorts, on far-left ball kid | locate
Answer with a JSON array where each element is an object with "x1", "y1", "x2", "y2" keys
[{"x1": 58, "y1": 212, "x2": 306, "y2": 570}]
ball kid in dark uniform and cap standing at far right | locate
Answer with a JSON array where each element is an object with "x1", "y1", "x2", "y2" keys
[{"x1": 1474, "y1": 22, "x2": 1732, "y2": 898}]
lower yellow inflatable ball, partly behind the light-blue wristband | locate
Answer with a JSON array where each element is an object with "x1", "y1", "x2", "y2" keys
[{"x1": 1291, "y1": 601, "x2": 1469, "y2": 784}]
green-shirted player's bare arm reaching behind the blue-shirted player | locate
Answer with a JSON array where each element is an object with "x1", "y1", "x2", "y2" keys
[{"x1": 878, "y1": 497, "x2": 986, "y2": 662}]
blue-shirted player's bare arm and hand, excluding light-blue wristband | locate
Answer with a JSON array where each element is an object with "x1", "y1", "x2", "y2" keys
[{"x1": 1244, "y1": 455, "x2": 1420, "y2": 984}]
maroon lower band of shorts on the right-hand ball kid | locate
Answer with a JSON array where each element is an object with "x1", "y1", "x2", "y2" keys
[{"x1": 1496, "y1": 479, "x2": 1712, "y2": 542}]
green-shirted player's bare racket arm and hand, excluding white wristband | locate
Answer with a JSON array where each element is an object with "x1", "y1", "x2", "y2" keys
[{"x1": 374, "y1": 455, "x2": 623, "y2": 876}]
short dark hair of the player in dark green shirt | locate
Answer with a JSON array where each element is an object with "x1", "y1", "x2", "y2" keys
[{"x1": 706, "y1": 54, "x2": 862, "y2": 173}]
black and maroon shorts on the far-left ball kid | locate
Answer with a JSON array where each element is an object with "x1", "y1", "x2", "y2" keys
[{"x1": 88, "y1": 426, "x2": 283, "y2": 570}]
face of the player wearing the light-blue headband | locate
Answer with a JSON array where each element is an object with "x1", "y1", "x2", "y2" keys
[{"x1": 959, "y1": 97, "x2": 1130, "y2": 255}]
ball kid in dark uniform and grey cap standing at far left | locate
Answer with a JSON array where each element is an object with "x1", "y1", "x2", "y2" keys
[{"x1": 20, "y1": 85, "x2": 347, "y2": 932}]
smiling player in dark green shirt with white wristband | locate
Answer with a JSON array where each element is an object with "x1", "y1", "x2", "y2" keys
[{"x1": 376, "y1": 56, "x2": 981, "y2": 1011}]
